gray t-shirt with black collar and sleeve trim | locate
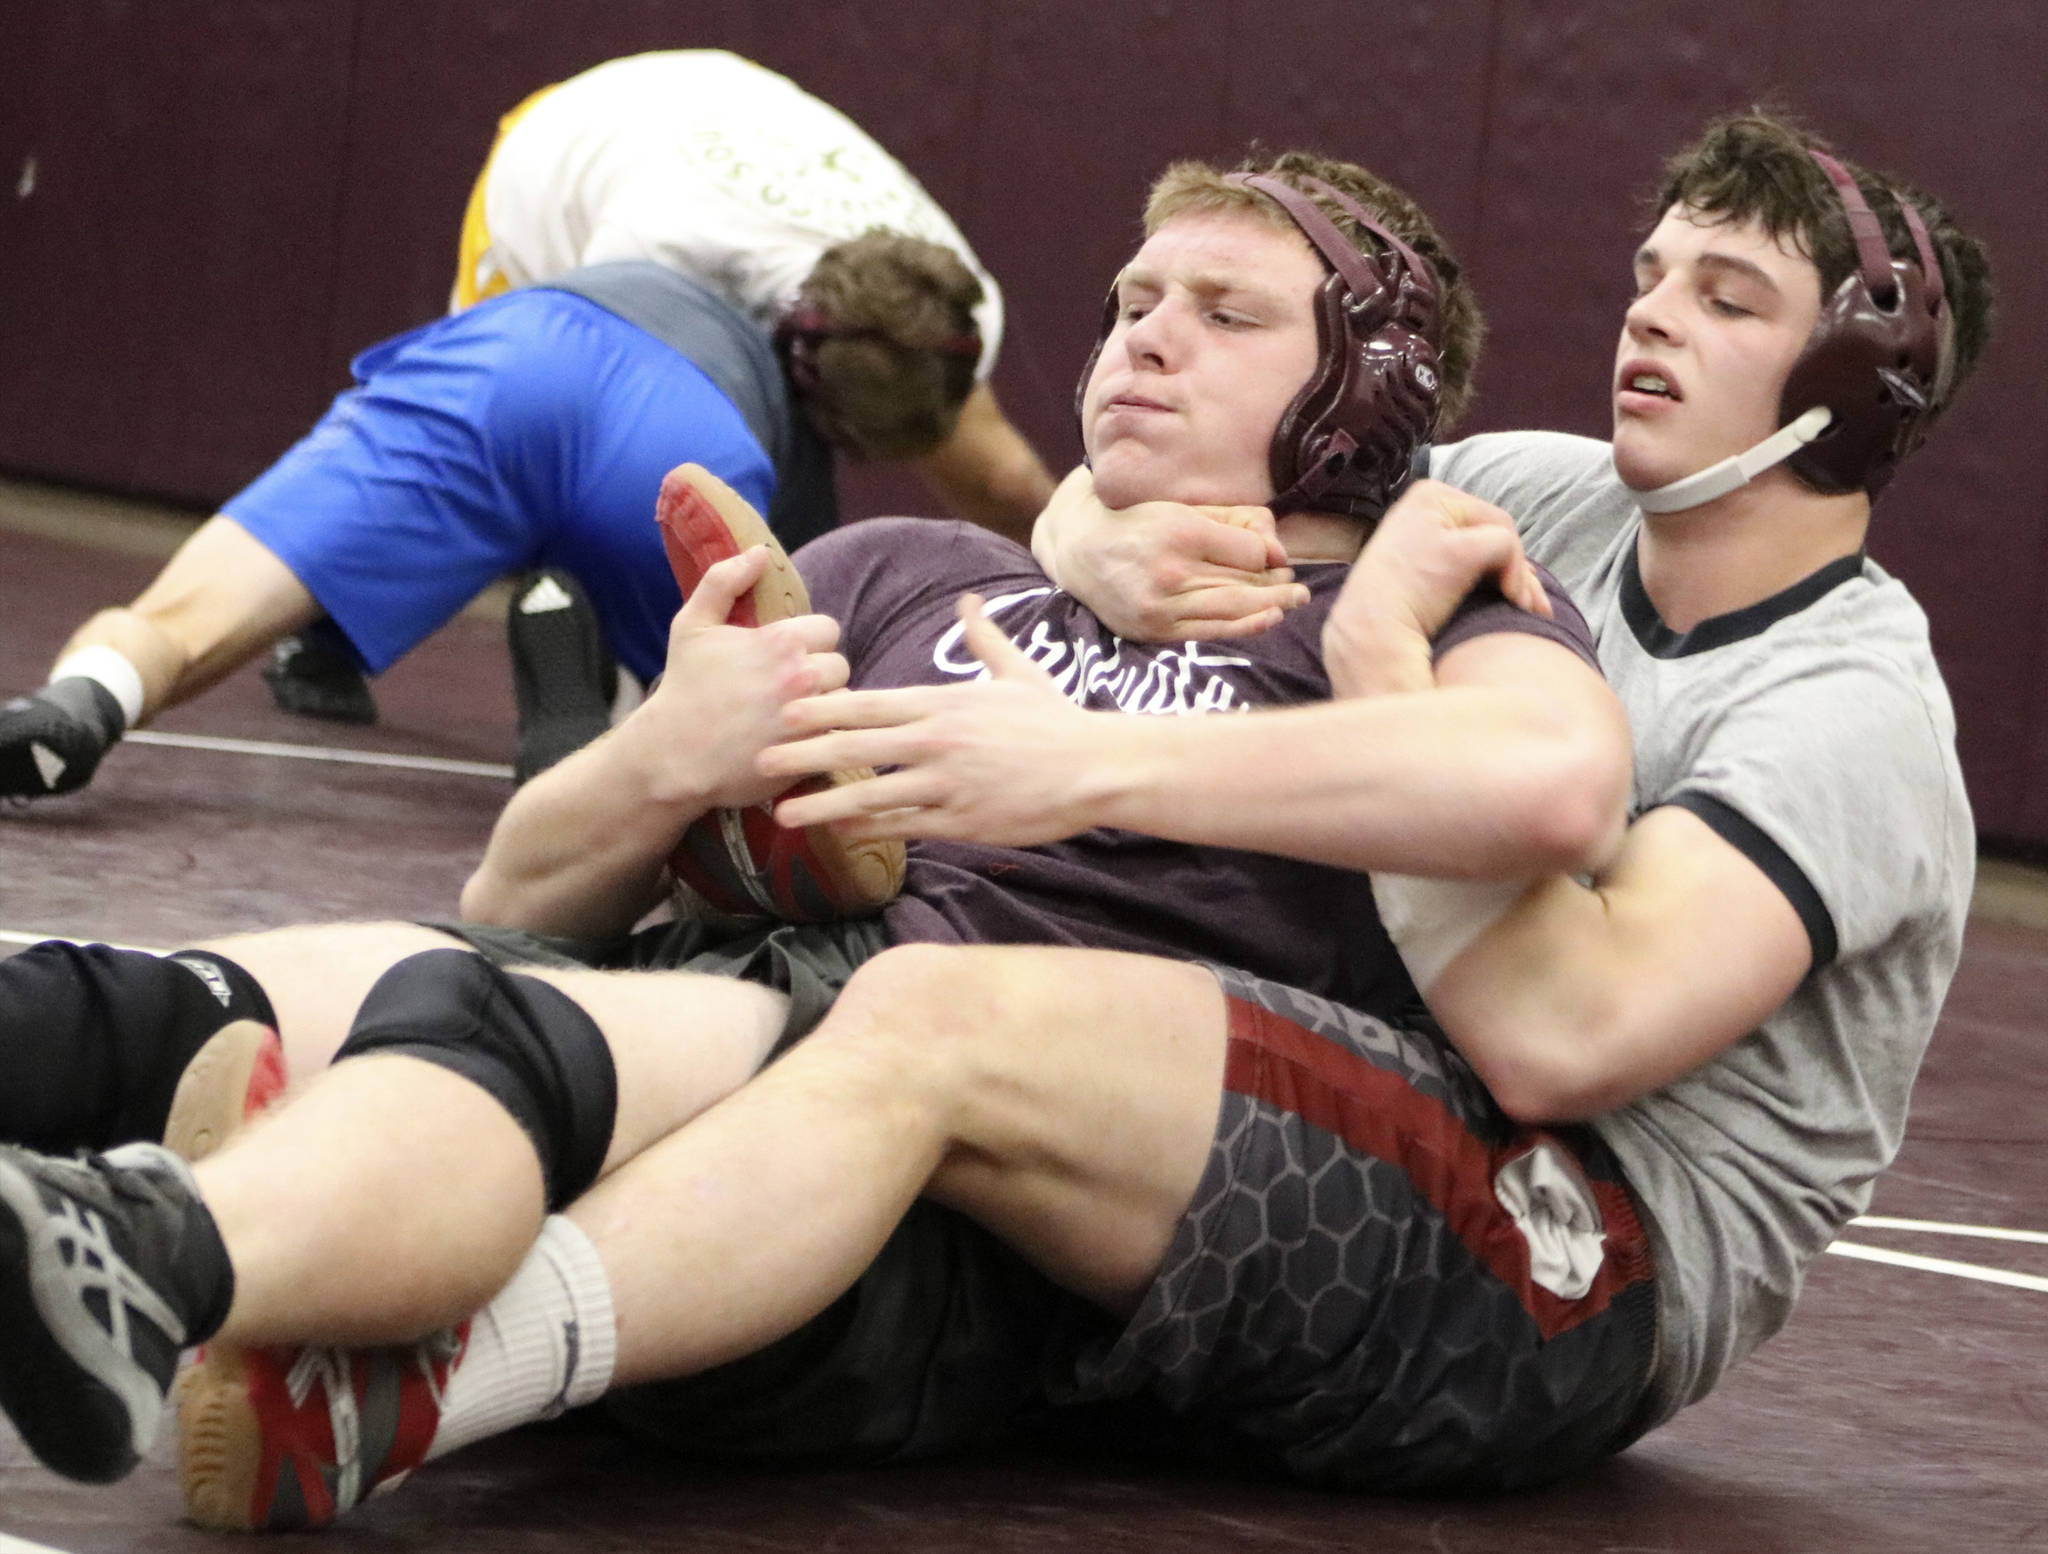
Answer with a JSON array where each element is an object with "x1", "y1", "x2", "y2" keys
[{"x1": 1432, "y1": 432, "x2": 1976, "y2": 1421}]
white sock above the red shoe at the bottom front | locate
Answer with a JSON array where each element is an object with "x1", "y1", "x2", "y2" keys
[{"x1": 426, "y1": 1214, "x2": 618, "y2": 1462}]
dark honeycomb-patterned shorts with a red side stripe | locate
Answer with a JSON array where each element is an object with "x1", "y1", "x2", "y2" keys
[{"x1": 1053, "y1": 973, "x2": 1657, "y2": 1493}]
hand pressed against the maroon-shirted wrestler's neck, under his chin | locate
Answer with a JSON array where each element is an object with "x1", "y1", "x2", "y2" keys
[{"x1": 1032, "y1": 469, "x2": 1309, "y2": 643}]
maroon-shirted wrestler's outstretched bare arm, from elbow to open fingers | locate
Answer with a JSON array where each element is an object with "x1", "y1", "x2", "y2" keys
[{"x1": 758, "y1": 614, "x2": 1630, "y2": 878}]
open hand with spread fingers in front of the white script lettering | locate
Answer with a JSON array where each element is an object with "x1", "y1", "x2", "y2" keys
[{"x1": 760, "y1": 594, "x2": 1130, "y2": 846}]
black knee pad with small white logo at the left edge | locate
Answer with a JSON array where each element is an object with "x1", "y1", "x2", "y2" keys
[{"x1": 0, "y1": 940, "x2": 276, "y2": 1153}]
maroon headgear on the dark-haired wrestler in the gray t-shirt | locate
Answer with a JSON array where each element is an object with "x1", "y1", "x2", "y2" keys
[{"x1": 1778, "y1": 152, "x2": 1952, "y2": 498}]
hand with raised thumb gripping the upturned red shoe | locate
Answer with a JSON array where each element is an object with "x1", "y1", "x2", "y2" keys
[{"x1": 621, "y1": 545, "x2": 848, "y2": 807}]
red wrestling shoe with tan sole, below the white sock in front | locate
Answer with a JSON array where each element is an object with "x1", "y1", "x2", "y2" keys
[{"x1": 178, "y1": 1323, "x2": 469, "y2": 1531}]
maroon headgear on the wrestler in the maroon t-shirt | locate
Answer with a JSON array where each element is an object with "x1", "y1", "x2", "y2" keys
[{"x1": 1073, "y1": 172, "x2": 1440, "y2": 518}]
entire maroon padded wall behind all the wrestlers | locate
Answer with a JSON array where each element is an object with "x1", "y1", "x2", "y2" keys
[{"x1": 0, "y1": 0, "x2": 2048, "y2": 841}]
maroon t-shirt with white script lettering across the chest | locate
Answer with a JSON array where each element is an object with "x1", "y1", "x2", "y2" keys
[{"x1": 797, "y1": 518, "x2": 1593, "y2": 1016}]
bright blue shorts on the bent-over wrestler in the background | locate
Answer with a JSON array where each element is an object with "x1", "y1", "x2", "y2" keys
[{"x1": 223, "y1": 289, "x2": 774, "y2": 680}]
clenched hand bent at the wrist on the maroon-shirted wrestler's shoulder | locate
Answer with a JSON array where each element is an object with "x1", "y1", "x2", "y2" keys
[{"x1": 1323, "y1": 481, "x2": 1550, "y2": 696}]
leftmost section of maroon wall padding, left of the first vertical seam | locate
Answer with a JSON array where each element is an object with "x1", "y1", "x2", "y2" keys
[{"x1": 0, "y1": 0, "x2": 352, "y2": 500}]
